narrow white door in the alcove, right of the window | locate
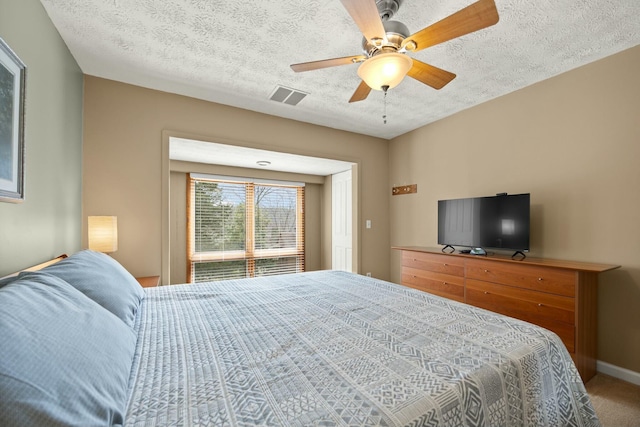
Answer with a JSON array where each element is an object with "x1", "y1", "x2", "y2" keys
[{"x1": 331, "y1": 170, "x2": 353, "y2": 271}]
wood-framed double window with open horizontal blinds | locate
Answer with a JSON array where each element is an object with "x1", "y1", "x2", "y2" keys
[{"x1": 187, "y1": 174, "x2": 304, "y2": 282}]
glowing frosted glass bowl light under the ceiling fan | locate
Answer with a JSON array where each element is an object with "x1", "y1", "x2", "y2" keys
[{"x1": 358, "y1": 52, "x2": 413, "y2": 90}]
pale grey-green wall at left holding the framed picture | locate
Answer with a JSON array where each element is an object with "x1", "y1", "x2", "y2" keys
[{"x1": 0, "y1": 0, "x2": 83, "y2": 277}]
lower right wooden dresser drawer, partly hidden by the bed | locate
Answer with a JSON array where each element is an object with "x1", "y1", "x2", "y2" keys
[{"x1": 466, "y1": 279, "x2": 575, "y2": 352}]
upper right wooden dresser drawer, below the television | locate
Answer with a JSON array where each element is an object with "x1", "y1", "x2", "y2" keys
[{"x1": 466, "y1": 259, "x2": 578, "y2": 297}]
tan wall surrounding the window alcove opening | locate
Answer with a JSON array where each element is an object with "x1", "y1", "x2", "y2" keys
[{"x1": 83, "y1": 76, "x2": 390, "y2": 279}]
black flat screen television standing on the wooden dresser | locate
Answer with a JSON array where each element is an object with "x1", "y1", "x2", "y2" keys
[{"x1": 438, "y1": 193, "x2": 530, "y2": 256}]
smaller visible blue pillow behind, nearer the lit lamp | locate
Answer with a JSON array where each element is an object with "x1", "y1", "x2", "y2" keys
[{"x1": 41, "y1": 250, "x2": 145, "y2": 326}]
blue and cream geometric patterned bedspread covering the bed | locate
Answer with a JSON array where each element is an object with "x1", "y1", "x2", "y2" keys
[{"x1": 126, "y1": 271, "x2": 599, "y2": 427}]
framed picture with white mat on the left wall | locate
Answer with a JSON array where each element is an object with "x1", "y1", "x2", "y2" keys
[{"x1": 0, "y1": 38, "x2": 26, "y2": 203}]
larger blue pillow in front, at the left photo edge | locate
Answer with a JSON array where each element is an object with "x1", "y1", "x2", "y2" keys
[{"x1": 0, "y1": 272, "x2": 136, "y2": 426}]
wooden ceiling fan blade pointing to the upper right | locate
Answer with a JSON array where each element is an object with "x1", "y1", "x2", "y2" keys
[{"x1": 402, "y1": 0, "x2": 500, "y2": 51}]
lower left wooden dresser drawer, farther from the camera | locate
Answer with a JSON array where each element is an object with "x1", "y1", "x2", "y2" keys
[{"x1": 402, "y1": 267, "x2": 464, "y2": 302}]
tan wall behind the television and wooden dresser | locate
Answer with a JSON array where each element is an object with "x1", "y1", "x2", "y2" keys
[{"x1": 389, "y1": 46, "x2": 640, "y2": 372}]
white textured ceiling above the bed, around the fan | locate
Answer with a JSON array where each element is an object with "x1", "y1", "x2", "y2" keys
[{"x1": 41, "y1": 0, "x2": 640, "y2": 139}]
